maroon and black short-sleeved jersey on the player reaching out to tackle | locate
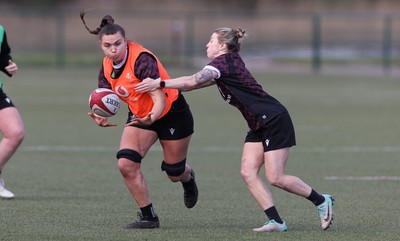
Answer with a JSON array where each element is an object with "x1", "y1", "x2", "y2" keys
[{"x1": 204, "y1": 52, "x2": 287, "y2": 130}]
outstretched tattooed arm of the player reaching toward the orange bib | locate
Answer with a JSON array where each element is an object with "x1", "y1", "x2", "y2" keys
[{"x1": 135, "y1": 69, "x2": 218, "y2": 92}]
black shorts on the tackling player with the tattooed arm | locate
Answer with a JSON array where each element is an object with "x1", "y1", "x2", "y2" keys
[{"x1": 245, "y1": 112, "x2": 296, "y2": 152}]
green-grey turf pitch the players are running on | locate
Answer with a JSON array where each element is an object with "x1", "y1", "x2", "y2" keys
[{"x1": 0, "y1": 68, "x2": 400, "y2": 241}]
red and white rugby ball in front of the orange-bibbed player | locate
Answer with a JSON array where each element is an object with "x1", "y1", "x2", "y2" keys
[{"x1": 89, "y1": 88, "x2": 120, "y2": 117}]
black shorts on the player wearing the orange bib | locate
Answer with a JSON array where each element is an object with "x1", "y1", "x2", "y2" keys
[{"x1": 126, "y1": 94, "x2": 194, "y2": 140}]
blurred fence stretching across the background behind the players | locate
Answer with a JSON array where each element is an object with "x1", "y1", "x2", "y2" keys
[{"x1": 0, "y1": 7, "x2": 400, "y2": 74}]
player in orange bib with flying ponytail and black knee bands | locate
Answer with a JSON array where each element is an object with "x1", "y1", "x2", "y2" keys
[{"x1": 81, "y1": 12, "x2": 198, "y2": 229}]
